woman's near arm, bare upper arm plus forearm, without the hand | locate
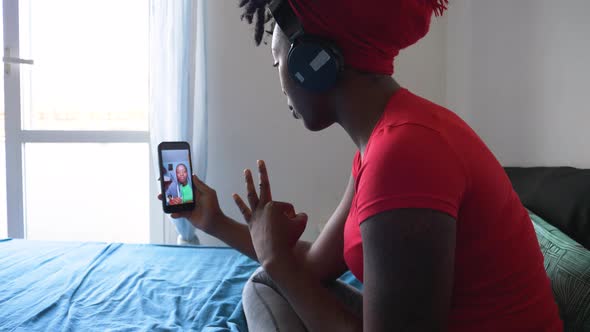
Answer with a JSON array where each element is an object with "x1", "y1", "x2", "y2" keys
[{"x1": 264, "y1": 209, "x2": 456, "y2": 332}]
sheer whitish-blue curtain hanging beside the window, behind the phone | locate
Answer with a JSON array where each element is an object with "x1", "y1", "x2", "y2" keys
[{"x1": 149, "y1": 0, "x2": 207, "y2": 242}]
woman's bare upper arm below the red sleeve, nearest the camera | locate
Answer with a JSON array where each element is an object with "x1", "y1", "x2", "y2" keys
[{"x1": 361, "y1": 209, "x2": 456, "y2": 331}]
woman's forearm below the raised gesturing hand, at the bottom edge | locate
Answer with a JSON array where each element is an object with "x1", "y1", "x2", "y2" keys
[{"x1": 264, "y1": 253, "x2": 363, "y2": 332}]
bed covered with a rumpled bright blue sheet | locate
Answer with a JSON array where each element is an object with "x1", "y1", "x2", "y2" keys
[{"x1": 0, "y1": 239, "x2": 358, "y2": 331}]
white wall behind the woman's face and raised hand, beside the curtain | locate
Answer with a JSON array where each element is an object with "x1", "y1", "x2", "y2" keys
[{"x1": 200, "y1": 0, "x2": 446, "y2": 245}]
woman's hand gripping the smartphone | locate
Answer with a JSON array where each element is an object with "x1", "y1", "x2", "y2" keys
[{"x1": 158, "y1": 175, "x2": 225, "y2": 234}]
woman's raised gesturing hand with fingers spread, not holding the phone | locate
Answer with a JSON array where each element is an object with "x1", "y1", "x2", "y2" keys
[{"x1": 233, "y1": 160, "x2": 307, "y2": 266}]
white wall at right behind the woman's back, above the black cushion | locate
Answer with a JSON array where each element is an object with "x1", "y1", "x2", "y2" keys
[{"x1": 446, "y1": 0, "x2": 590, "y2": 168}]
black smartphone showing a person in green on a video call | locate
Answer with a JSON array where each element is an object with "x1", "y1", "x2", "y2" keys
[{"x1": 158, "y1": 142, "x2": 195, "y2": 213}]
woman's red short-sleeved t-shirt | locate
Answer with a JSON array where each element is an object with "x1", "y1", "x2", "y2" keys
[{"x1": 344, "y1": 89, "x2": 562, "y2": 332}]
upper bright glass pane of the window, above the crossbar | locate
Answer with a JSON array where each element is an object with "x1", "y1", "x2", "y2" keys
[{"x1": 20, "y1": 0, "x2": 149, "y2": 132}]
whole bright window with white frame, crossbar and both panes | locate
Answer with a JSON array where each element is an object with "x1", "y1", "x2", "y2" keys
[{"x1": 0, "y1": 0, "x2": 161, "y2": 242}]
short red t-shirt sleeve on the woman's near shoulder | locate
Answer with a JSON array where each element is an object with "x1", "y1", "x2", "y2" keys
[{"x1": 356, "y1": 124, "x2": 467, "y2": 223}]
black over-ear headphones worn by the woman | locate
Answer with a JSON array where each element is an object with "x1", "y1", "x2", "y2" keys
[{"x1": 269, "y1": 0, "x2": 344, "y2": 92}]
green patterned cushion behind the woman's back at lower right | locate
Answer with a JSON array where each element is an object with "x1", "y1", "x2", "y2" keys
[{"x1": 529, "y1": 212, "x2": 590, "y2": 331}]
